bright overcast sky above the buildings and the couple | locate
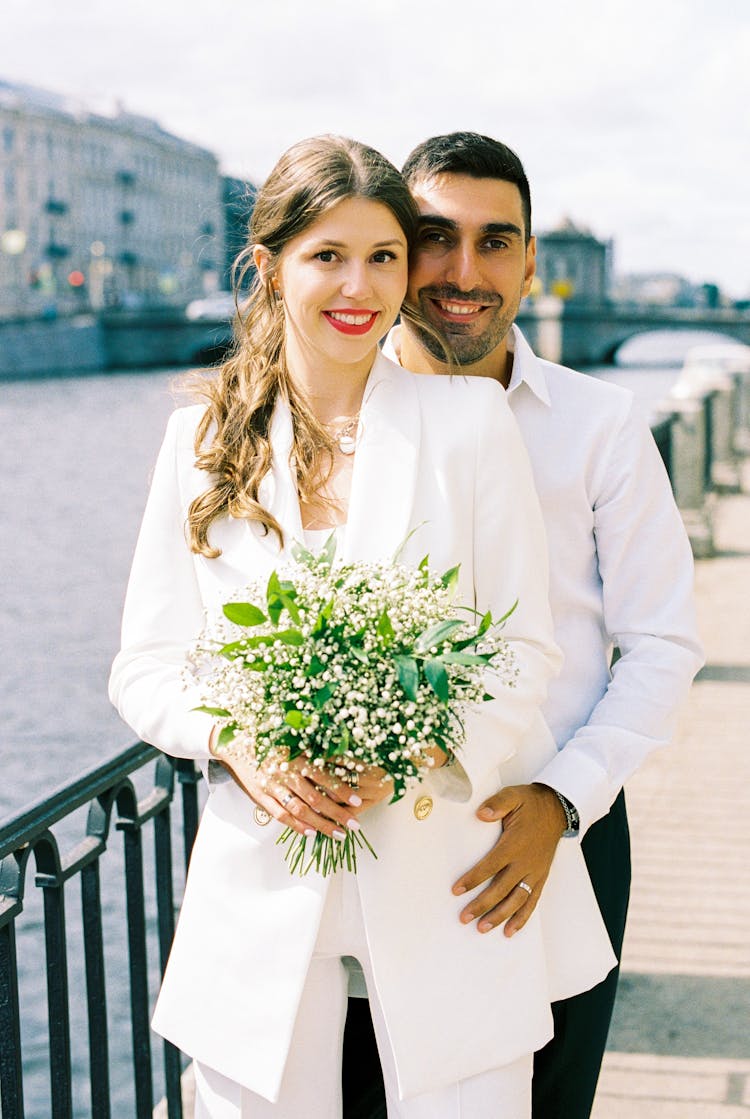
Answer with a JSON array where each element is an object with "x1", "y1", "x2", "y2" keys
[{"x1": 0, "y1": 0, "x2": 750, "y2": 297}]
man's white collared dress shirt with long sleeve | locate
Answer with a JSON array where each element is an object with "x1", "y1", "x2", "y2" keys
[{"x1": 385, "y1": 326, "x2": 703, "y2": 836}]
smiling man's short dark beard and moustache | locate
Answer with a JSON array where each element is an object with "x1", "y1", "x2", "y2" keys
[{"x1": 410, "y1": 286, "x2": 521, "y2": 366}]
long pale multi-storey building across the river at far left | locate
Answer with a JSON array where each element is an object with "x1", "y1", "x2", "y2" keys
[{"x1": 0, "y1": 82, "x2": 224, "y2": 318}]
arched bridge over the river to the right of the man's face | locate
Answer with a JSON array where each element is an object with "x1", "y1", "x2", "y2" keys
[{"x1": 517, "y1": 298, "x2": 750, "y2": 366}]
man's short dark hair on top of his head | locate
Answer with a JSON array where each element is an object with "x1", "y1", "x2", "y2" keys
[{"x1": 401, "y1": 132, "x2": 532, "y2": 241}]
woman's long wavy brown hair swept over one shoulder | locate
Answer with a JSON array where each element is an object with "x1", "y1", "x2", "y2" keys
[{"x1": 188, "y1": 135, "x2": 434, "y2": 558}]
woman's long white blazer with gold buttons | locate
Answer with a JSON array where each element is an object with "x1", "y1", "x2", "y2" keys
[{"x1": 110, "y1": 355, "x2": 616, "y2": 1100}]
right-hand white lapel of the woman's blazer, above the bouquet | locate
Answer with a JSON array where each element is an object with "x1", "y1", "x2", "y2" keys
[{"x1": 343, "y1": 352, "x2": 421, "y2": 560}]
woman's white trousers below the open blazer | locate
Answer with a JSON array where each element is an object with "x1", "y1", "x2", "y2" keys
[{"x1": 195, "y1": 873, "x2": 533, "y2": 1119}]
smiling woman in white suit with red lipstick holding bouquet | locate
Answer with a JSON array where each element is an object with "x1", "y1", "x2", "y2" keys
[{"x1": 111, "y1": 138, "x2": 615, "y2": 1119}]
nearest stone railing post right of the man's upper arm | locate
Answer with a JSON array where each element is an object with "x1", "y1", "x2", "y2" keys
[{"x1": 657, "y1": 396, "x2": 714, "y2": 560}]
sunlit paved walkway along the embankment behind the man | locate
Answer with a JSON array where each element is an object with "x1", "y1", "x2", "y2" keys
[{"x1": 593, "y1": 474, "x2": 750, "y2": 1119}]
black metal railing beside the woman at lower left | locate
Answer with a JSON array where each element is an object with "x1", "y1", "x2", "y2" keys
[{"x1": 0, "y1": 742, "x2": 200, "y2": 1119}]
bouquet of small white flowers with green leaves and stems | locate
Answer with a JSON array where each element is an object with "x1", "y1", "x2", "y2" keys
[{"x1": 188, "y1": 535, "x2": 517, "y2": 875}]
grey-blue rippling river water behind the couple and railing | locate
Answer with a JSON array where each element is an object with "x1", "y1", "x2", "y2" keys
[{"x1": 0, "y1": 326, "x2": 738, "y2": 1119}]
